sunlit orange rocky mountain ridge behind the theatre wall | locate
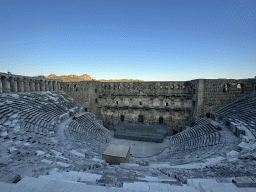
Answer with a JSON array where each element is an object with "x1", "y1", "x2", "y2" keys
[{"x1": 34, "y1": 74, "x2": 144, "y2": 82}]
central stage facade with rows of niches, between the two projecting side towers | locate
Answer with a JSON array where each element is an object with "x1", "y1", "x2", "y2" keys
[{"x1": 99, "y1": 81, "x2": 192, "y2": 130}]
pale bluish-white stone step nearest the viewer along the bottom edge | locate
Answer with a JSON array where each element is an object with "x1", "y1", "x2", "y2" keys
[{"x1": 0, "y1": 177, "x2": 200, "y2": 192}]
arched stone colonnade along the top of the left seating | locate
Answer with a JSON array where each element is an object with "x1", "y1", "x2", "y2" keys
[{"x1": 0, "y1": 73, "x2": 62, "y2": 93}]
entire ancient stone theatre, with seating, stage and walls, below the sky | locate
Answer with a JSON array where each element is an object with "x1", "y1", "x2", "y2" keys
[{"x1": 0, "y1": 73, "x2": 256, "y2": 192}]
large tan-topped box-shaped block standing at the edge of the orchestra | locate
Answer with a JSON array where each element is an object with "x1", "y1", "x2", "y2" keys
[{"x1": 102, "y1": 144, "x2": 130, "y2": 165}]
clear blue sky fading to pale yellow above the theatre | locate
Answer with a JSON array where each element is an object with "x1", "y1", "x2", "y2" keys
[{"x1": 0, "y1": 0, "x2": 256, "y2": 81}]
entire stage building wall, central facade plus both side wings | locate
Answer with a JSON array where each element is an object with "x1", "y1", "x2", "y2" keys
[{"x1": 61, "y1": 78, "x2": 256, "y2": 131}]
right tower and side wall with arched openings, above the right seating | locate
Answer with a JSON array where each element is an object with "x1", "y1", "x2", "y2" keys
[{"x1": 191, "y1": 78, "x2": 256, "y2": 121}]
